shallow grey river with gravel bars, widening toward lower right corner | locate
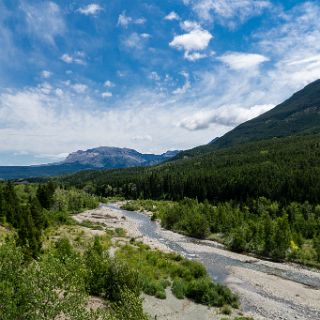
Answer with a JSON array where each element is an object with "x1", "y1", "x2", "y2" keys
[{"x1": 107, "y1": 204, "x2": 320, "y2": 320}]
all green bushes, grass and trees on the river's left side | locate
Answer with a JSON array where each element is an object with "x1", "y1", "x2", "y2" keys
[{"x1": 0, "y1": 183, "x2": 238, "y2": 320}]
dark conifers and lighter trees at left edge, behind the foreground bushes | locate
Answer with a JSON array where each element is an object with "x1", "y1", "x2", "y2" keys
[{"x1": 0, "y1": 182, "x2": 99, "y2": 257}]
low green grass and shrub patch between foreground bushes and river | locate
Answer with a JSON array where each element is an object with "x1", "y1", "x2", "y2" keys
[{"x1": 116, "y1": 242, "x2": 238, "y2": 307}]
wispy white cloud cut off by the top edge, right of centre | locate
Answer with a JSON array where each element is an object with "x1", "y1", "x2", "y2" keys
[{"x1": 183, "y1": 0, "x2": 272, "y2": 28}]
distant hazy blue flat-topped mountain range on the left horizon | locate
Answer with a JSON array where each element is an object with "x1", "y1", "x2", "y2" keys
[{"x1": 0, "y1": 147, "x2": 180, "y2": 180}]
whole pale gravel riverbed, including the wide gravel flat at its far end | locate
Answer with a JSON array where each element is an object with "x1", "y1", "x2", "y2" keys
[{"x1": 75, "y1": 204, "x2": 320, "y2": 320}]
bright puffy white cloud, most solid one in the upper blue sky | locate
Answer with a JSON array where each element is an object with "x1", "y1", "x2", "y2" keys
[{"x1": 169, "y1": 27, "x2": 213, "y2": 61}]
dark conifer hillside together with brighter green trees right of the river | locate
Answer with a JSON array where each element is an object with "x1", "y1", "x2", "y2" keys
[{"x1": 62, "y1": 134, "x2": 320, "y2": 265}]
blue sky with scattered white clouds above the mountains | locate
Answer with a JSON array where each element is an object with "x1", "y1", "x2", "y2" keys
[{"x1": 0, "y1": 0, "x2": 320, "y2": 165}]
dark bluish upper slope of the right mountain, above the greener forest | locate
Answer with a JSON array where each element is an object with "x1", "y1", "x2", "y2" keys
[{"x1": 177, "y1": 80, "x2": 320, "y2": 158}]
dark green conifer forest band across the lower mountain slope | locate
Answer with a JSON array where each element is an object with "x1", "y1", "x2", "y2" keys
[{"x1": 62, "y1": 135, "x2": 320, "y2": 204}]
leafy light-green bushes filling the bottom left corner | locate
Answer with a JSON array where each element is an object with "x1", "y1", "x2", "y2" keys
[{"x1": 0, "y1": 239, "x2": 148, "y2": 320}]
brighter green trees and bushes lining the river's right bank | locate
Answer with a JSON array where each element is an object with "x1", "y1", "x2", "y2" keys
[{"x1": 123, "y1": 198, "x2": 320, "y2": 267}]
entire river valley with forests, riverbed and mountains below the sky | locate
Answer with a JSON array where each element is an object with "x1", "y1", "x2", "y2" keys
[{"x1": 0, "y1": 81, "x2": 320, "y2": 320}]
